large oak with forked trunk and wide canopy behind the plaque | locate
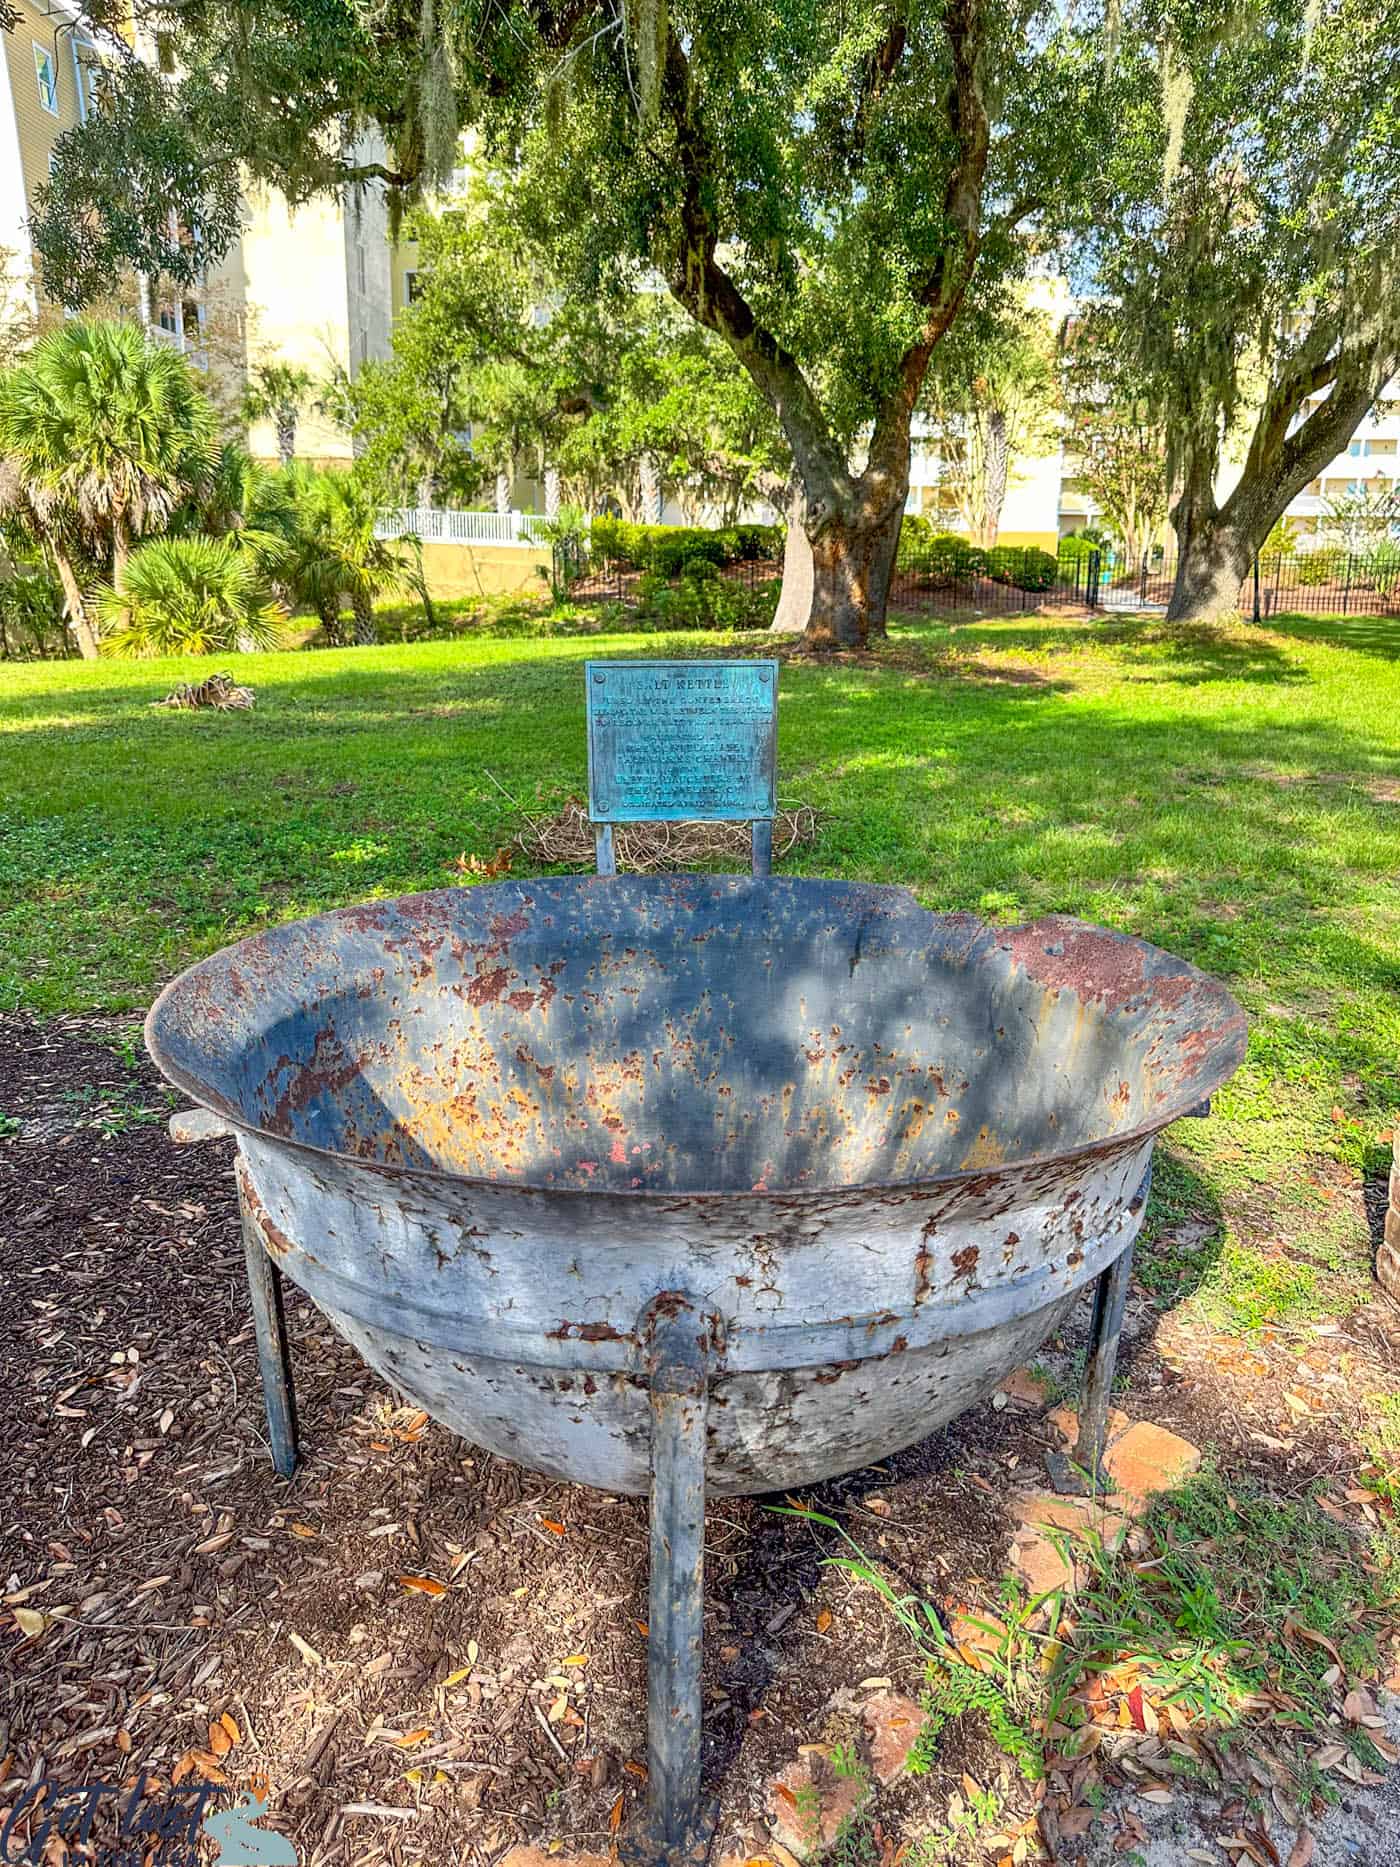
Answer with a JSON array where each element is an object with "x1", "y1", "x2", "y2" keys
[{"x1": 35, "y1": 0, "x2": 1114, "y2": 640}]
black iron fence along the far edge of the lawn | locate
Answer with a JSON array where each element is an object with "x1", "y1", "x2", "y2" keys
[{"x1": 554, "y1": 545, "x2": 1400, "y2": 627}]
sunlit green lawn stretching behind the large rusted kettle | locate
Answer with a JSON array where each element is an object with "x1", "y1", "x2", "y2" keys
[{"x1": 0, "y1": 616, "x2": 1400, "y2": 1309}]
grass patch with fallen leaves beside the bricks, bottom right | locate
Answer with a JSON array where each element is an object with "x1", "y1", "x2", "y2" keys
[{"x1": 786, "y1": 1469, "x2": 1396, "y2": 1790}]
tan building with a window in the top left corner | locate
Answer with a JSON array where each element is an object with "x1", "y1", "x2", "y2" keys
[{"x1": 0, "y1": 0, "x2": 101, "y2": 317}]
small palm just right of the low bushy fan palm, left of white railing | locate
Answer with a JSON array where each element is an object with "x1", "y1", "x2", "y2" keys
[{"x1": 284, "y1": 472, "x2": 413, "y2": 646}]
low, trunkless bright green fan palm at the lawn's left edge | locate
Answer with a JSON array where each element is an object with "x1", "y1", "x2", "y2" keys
[{"x1": 97, "y1": 534, "x2": 287, "y2": 655}]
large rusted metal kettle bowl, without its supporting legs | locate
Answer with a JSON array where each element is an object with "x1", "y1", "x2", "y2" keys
[{"x1": 147, "y1": 876, "x2": 1245, "y2": 1494}]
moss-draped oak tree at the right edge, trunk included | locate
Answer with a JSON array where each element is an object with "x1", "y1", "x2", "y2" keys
[{"x1": 1083, "y1": 0, "x2": 1400, "y2": 616}]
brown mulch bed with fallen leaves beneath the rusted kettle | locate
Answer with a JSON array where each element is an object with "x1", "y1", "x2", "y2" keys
[{"x1": 0, "y1": 1016, "x2": 1394, "y2": 1867}]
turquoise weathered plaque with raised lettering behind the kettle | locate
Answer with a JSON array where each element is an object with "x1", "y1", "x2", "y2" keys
[{"x1": 584, "y1": 661, "x2": 778, "y2": 823}]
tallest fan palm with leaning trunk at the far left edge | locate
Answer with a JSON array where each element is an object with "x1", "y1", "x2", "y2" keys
[{"x1": 0, "y1": 319, "x2": 217, "y2": 657}]
